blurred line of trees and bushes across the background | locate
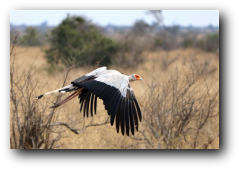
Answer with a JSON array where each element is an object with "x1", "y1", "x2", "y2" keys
[{"x1": 12, "y1": 14, "x2": 219, "y2": 68}]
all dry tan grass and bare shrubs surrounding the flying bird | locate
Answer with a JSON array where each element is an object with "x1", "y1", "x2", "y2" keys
[{"x1": 10, "y1": 37, "x2": 219, "y2": 149}]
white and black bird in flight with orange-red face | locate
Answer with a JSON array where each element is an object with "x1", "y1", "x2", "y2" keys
[{"x1": 36, "y1": 67, "x2": 143, "y2": 136}]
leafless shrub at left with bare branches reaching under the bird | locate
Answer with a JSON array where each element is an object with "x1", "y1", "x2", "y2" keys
[{"x1": 10, "y1": 32, "x2": 108, "y2": 149}]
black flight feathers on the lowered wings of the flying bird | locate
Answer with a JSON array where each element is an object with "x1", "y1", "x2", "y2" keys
[{"x1": 74, "y1": 76, "x2": 142, "y2": 136}]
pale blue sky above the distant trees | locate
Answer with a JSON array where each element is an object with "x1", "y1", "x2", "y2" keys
[{"x1": 10, "y1": 10, "x2": 219, "y2": 26}]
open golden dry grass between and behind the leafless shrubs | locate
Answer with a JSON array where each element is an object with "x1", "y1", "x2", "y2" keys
[{"x1": 10, "y1": 47, "x2": 219, "y2": 149}]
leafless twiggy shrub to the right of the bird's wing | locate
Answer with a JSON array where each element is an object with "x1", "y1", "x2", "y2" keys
[{"x1": 134, "y1": 57, "x2": 219, "y2": 149}]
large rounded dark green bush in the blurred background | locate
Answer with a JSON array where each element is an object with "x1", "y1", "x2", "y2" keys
[{"x1": 46, "y1": 16, "x2": 119, "y2": 66}]
